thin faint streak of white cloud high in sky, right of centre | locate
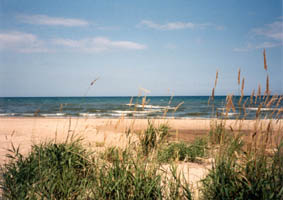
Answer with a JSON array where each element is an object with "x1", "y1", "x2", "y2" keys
[{"x1": 138, "y1": 20, "x2": 224, "y2": 31}]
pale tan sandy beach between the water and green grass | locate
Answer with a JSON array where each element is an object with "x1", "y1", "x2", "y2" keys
[{"x1": 0, "y1": 117, "x2": 282, "y2": 163}]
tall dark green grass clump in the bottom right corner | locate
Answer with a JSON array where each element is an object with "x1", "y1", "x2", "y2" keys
[{"x1": 202, "y1": 141, "x2": 283, "y2": 200}]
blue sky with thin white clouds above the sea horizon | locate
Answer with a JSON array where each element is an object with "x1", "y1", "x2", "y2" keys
[{"x1": 0, "y1": 0, "x2": 283, "y2": 97}]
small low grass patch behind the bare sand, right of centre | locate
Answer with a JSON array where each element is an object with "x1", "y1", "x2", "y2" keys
[{"x1": 157, "y1": 138, "x2": 207, "y2": 163}]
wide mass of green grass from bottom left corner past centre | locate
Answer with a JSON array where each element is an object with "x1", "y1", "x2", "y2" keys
[{"x1": 0, "y1": 130, "x2": 191, "y2": 200}]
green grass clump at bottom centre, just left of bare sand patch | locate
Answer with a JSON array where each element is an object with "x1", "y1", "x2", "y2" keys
[{"x1": 91, "y1": 148, "x2": 163, "y2": 199}]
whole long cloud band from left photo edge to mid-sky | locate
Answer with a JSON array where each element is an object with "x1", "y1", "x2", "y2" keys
[{"x1": 0, "y1": 31, "x2": 146, "y2": 53}]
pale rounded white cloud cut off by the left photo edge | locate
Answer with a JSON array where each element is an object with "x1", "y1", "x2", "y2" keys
[{"x1": 0, "y1": 31, "x2": 49, "y2": 53}]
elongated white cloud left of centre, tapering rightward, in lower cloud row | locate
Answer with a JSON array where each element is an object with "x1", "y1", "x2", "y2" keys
[{"x1": 53, "y1": 37, "x2": 146, "y2": 52}]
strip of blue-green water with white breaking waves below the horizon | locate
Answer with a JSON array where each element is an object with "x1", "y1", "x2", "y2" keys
[{"x1": 0, "y1": 96, "x2": 282, "y2": 119}]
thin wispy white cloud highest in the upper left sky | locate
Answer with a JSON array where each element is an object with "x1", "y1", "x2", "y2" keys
[{"x1": 18, "y1": 15, "x2": 89, "y2": 27}]
